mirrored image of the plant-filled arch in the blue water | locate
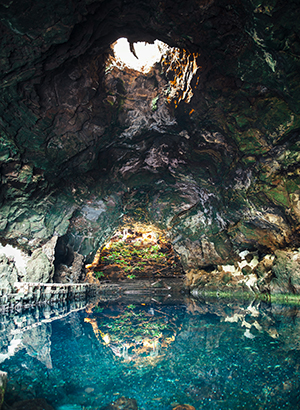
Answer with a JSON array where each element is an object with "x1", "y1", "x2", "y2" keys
[{"x1": 85, "y1": 303, "x2": 185, "y2": 367}]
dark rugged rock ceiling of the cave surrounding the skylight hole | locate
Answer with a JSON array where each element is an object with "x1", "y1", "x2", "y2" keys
[{"x1": 0, "y1": 0, "x2": 300, "y2": 269}]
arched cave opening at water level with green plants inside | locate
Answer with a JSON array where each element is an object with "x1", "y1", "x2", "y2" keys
[{"x1": 86, "y1": 223, "x2": 184, "y2": 283}]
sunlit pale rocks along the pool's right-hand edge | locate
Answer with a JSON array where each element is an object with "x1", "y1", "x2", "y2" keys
[{"x1": 186, "y1": 249, "x2": 300, "y2": 299}]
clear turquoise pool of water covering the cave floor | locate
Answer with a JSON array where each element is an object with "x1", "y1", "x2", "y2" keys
[{"x1": 0, "y1": 297, "x2": 300, "y2": 410}]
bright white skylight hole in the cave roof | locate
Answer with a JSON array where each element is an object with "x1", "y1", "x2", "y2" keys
[{"x1": 107, "y1": 37, "x2": 171, "y2": 73}]
